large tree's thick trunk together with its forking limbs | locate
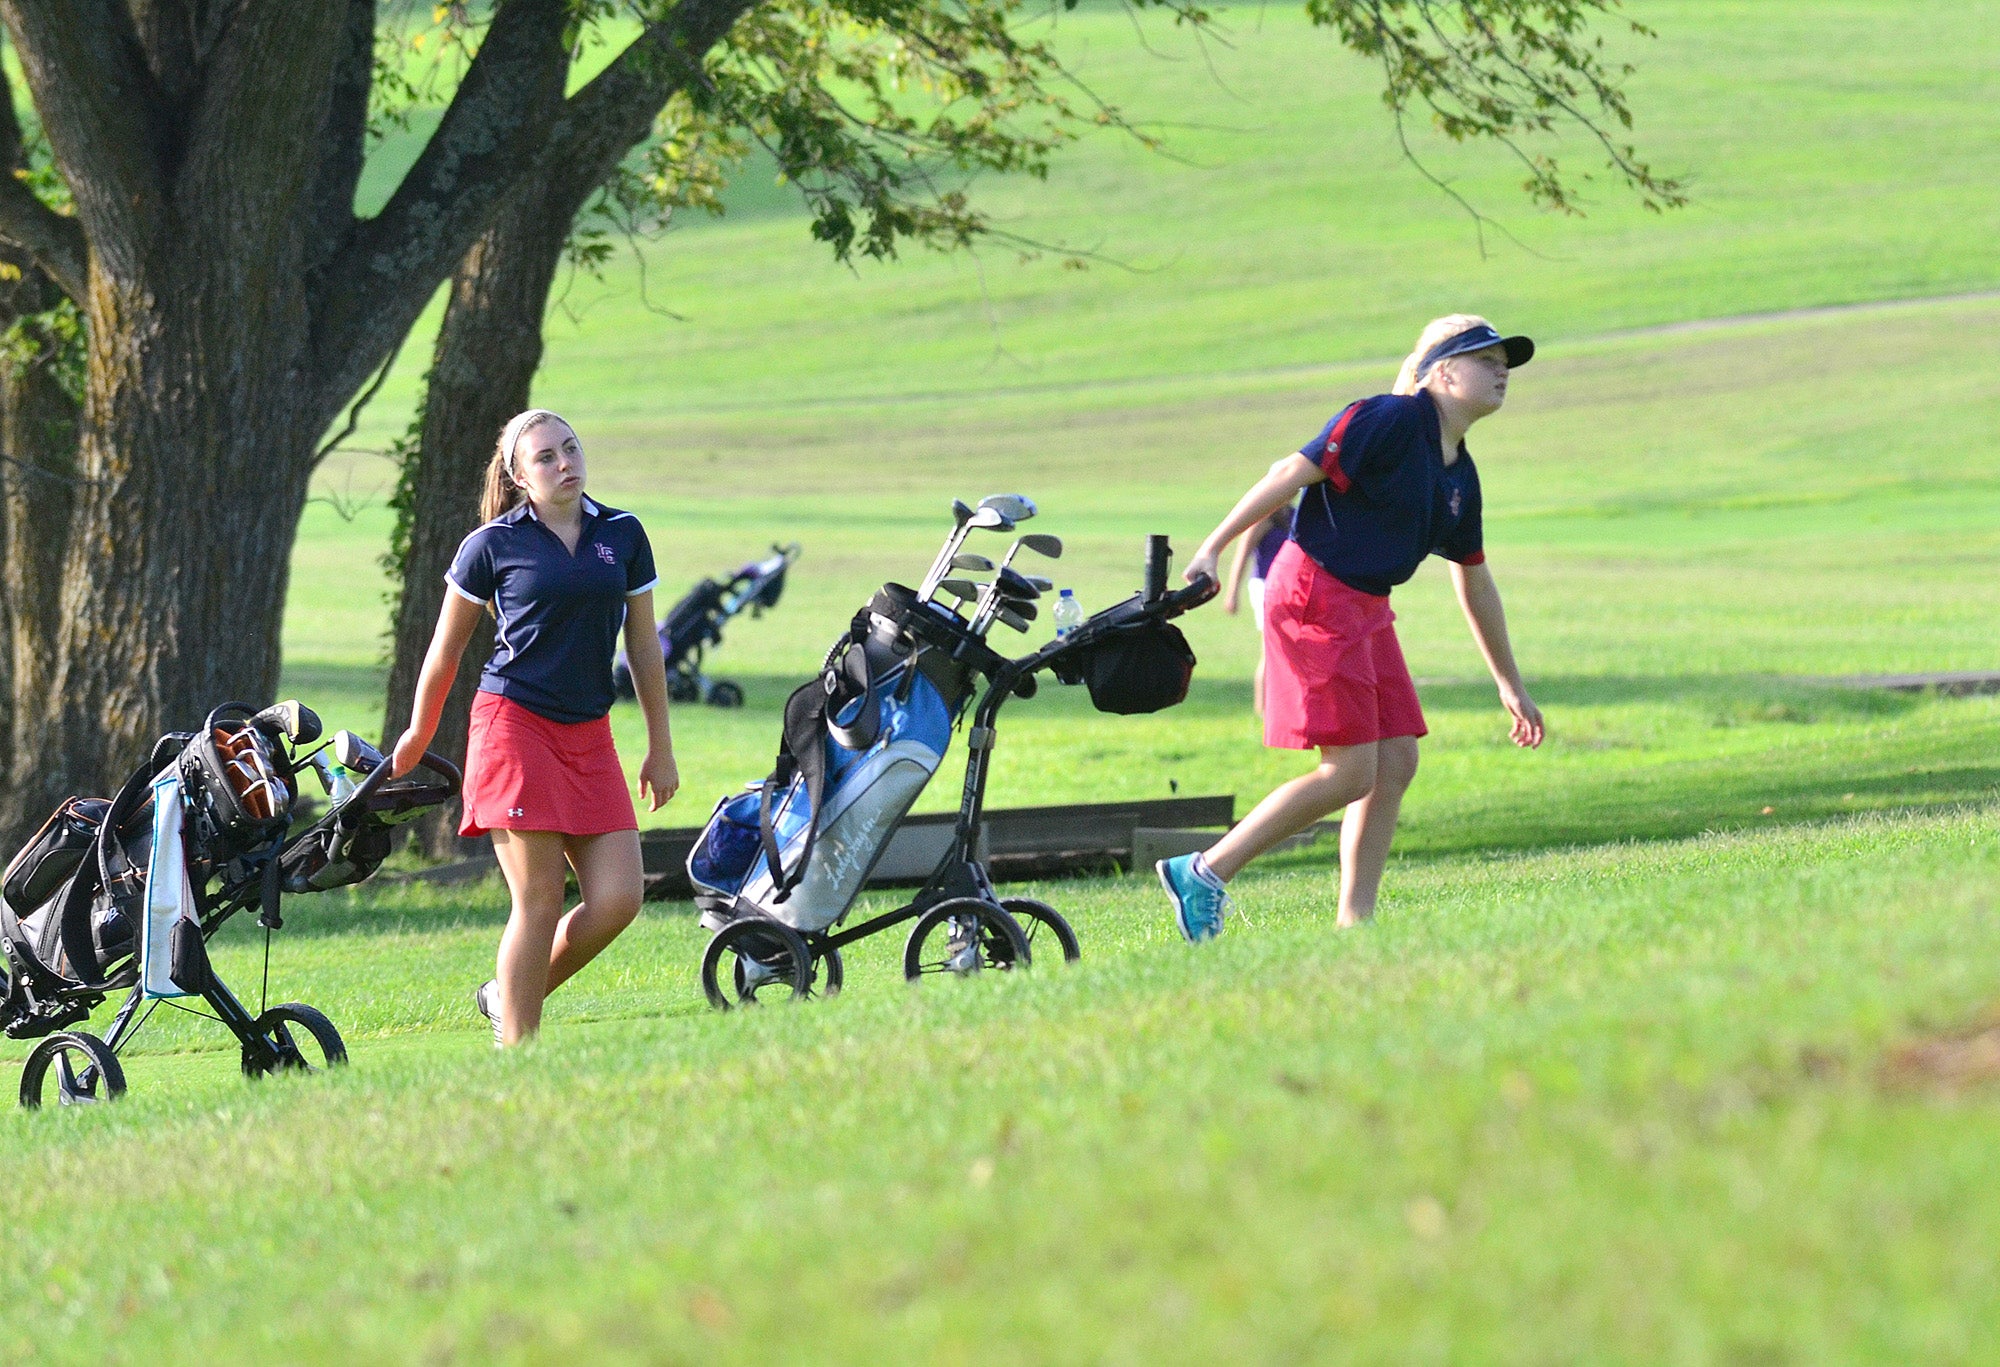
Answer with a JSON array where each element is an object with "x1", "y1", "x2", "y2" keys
[{"x1": 0, "y1": 0, "x2": 750, "y2": 833}]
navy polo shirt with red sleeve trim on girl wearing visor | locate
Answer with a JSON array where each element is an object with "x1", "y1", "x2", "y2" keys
[{"x1": 1292, "y1": 390, "x2": 1486, "y2": 596}]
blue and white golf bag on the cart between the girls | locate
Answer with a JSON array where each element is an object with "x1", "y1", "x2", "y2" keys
[{"x1": 688, "y1": 584, "x2": 976, "y2": 931}]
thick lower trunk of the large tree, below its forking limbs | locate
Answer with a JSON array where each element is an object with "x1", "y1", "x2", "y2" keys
[{"x1": 0, "y1": 265, "x2": 320, "y2": 827}]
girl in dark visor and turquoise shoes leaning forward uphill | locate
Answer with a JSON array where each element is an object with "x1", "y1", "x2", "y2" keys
[{"x1": 1156, "y1": 314, "x2": 1542, "y2": 939}]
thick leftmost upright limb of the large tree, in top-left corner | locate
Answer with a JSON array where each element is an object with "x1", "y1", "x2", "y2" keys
[{"x1": 4, "y1": 0, "x2": 172, "y2": 267}]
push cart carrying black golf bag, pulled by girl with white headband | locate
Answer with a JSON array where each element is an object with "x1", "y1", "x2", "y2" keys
[{"x1": 0, "y1": 701, "x2": 460, "y2": 1107}]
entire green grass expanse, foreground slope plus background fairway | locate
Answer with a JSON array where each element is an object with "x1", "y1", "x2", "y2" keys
[{"x1": 0, "y1": 2, "x2": 2000, "y2": 1363}]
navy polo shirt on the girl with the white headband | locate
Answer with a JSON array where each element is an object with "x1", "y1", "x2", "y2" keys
[{"x1": 444, "y1": 498, "x2": 660, "y2": 721}]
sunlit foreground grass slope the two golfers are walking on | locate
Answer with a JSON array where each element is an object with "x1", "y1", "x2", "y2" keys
[{"x1": 11, "y1": 803, "x2": 2000, "y2": 1363}]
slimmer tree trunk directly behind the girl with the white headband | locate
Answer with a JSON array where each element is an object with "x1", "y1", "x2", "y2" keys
[{"x1": 384, "y1": 176, "x2": 578, "y2": 857}]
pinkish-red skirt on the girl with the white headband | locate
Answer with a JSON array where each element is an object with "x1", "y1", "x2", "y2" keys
[{"x1": 458, "y1": 691, "x2": 638, "y2": 835}]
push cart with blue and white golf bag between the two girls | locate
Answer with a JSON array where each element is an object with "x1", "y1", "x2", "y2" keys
[{"x1": 688, "y1": 494, "x2": 1216, "y2": 1009}]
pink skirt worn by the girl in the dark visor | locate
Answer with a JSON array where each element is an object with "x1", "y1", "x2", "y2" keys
[{"x1": 1264, "y1": 542, "x2": 1428, "y2": 749}]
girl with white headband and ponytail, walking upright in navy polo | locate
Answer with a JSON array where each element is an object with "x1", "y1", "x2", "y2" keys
[{"x1": 394, "y1": 408, "x2": 680, "y2": 1045}]
